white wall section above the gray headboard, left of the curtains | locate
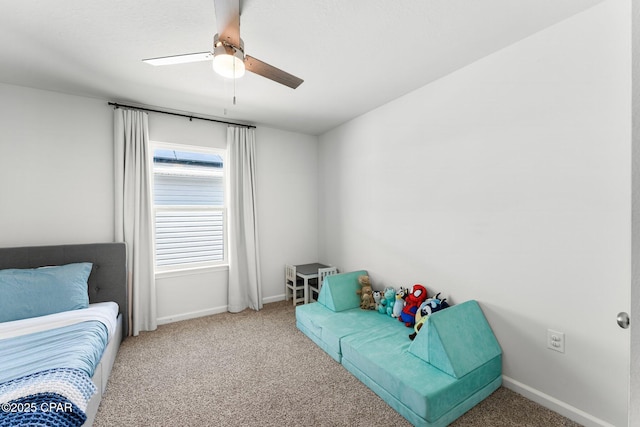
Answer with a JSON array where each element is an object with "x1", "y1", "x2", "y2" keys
[{"x1": 0, "y1": 84, "x2": 114, "y2": 247}]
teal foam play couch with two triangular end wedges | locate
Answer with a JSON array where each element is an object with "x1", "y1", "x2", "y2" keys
[{"x1": 296, "y1": 270, "x2": 502, "y2": 427}]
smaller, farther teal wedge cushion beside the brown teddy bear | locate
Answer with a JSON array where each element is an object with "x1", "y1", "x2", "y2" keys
[{"x1": 318, "y1": 270, "x2": 368, "y2": 311}]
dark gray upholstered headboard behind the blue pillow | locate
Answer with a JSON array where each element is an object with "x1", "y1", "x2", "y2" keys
[{"x1": 0, "y1": 243, "x2": 129, "y2": 338}]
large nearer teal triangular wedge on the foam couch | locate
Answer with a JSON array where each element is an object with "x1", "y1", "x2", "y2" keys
[{"x1": 409, "y1": 300, "x2": 502, "y2": 378}]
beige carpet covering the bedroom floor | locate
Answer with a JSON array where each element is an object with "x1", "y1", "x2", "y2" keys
[{"x1": 94, "y1": 301, "x2": 578, "y2": 427}]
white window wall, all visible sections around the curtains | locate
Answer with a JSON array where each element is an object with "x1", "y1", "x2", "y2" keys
[{"x1": 0, "y1": 84, "x2": 318, "y2": 323}]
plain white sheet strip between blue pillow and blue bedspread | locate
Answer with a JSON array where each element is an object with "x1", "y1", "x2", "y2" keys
[{"x1": 0, "y1": 302, "x2": 119, "y2": 341}]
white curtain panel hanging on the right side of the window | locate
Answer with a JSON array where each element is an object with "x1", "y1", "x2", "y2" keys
[{"x1": 227, "y1": 126, "x2": 262, "y2": 313}]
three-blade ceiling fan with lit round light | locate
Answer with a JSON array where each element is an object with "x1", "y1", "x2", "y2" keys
[{"x1": 142, "y1": 0, "x2": 304, "y2": 89}]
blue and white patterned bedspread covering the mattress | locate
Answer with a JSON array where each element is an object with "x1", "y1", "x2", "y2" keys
[{"x1": 0, "y1": 321, "x2": 109, "y2": 427}]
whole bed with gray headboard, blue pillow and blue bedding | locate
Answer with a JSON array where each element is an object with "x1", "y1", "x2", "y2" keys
[{"x1": 0, "y1": 243, "x2": 129, "y2": 426}]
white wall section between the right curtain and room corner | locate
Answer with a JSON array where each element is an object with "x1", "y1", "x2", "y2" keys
[{"x1": 256, "y1": 126, "x2": 318, "y2": 302}]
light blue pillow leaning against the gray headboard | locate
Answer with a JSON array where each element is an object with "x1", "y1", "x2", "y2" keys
[{"x1": 0, "y1": 262, "x2": 93, "y2": 322}]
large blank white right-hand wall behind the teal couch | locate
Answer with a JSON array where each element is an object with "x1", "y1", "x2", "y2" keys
[{"x1": 319, "y1": 0, "x2": 631, "y2": 426}]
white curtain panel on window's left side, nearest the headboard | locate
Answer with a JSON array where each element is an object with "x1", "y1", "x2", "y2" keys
[{"x1": 113, "y1": 108, "x2": 157, "y2": 335}]
